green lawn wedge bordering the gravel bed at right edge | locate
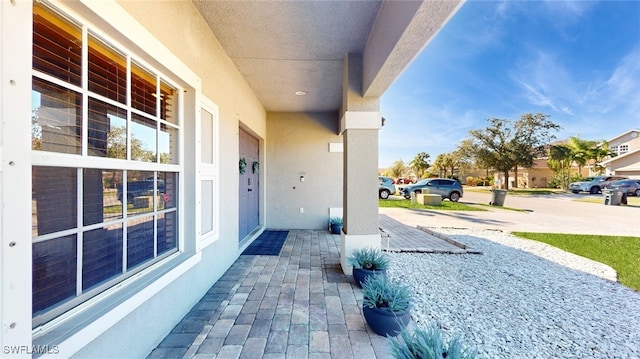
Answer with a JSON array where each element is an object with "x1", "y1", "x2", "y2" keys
[{"x1": 513, "y1": 232, "x2": 640, "y2": 291}]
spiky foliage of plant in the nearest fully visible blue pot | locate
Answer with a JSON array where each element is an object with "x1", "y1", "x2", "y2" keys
[{"x1": 362, "y1": 274, "x2": 411, "y2": 312}]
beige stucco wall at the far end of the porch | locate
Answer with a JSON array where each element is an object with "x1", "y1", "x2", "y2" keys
[{"x1": 264, "y1": 113, "x2": 343, "y2": 229}]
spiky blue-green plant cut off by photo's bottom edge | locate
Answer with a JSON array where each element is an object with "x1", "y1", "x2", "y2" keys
[{"x1": 389, "y1": 325, "x2": 476, "y2": 359}]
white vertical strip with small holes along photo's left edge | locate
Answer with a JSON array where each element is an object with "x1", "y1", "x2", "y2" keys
[{"x1": 0, "y1": 1, "x2": 33, "y2": 348}]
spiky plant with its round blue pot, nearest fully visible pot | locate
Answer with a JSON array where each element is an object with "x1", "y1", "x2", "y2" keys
[{"x1": 362, "y1": 275, "x2": 411, "y2": 336}]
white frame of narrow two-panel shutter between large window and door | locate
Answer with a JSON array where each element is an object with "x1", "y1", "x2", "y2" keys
[{"x1": 196, "y1": 96, "x2": 220, "y2": 250}]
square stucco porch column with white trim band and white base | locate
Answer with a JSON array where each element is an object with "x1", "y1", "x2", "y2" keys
[{"x1": 340, "y1": 54, "x2": 382, "y2": 274}]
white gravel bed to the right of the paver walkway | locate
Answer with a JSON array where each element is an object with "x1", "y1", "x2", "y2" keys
[{"x1": 388, "y1": 229, "x2": 640, "y2": 359}]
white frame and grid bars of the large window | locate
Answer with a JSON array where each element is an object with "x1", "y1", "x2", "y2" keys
[{"x1": 31, "y1": 2, "x2": 185, "y2": 332}]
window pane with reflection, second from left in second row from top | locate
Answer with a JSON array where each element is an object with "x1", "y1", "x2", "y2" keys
[{"x1": 88, "y1": 99, "x2": 127, "y2": 160}]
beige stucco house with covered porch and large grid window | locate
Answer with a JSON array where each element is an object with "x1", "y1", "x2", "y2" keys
[{"x1": 0, "y1": 0, "x2": 462, "y2": 358}]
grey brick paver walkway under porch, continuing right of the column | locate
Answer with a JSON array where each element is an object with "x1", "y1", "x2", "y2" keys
[{"x1": 148, "y1": 217, "x2": 470, "y2": 359}]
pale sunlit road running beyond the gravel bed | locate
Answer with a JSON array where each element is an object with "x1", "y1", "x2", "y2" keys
[{"x1": 379, "y1": 191, "x2": 640, "y2": 237}]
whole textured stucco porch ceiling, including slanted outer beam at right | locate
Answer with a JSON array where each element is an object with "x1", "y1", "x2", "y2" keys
[{"x1": 193, "y1": 0, "x2": 461, "y2": 112}]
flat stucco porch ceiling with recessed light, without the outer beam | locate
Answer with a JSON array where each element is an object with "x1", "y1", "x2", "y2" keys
[{"x1": 194, "y1": 1, "x2": 381, "y2": 112}]
